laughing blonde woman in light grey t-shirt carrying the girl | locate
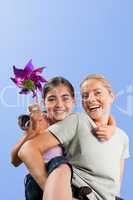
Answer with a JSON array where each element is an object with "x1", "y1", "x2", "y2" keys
[{"x1": 42, "y1": 75, "x2": 129, "y2": 200}]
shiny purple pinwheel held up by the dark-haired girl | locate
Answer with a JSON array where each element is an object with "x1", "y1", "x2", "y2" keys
[{"x1": 11, "y1": 60, "x2": 47, "y2": 97}]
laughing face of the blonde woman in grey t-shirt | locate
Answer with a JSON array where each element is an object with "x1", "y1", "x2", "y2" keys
[{"x1": 81, "y1": 79, "x2": 114, "y2": 122}]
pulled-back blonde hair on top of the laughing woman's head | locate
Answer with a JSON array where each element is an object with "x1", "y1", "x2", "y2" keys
[{"x1": 80, "y1": 74, "x2": 113, "y2": 94}]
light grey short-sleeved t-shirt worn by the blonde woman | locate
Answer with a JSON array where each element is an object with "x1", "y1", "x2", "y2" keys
[{"x1": 48, "y1": 113, "x2": 129, "y2": 200}]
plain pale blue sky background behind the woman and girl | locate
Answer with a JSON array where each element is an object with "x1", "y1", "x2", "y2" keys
[{"x1": 0, "y1": 0, "x2": 133, "y2": 200}]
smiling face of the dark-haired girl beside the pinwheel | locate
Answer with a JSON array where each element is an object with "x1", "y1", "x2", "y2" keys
[{"x1": 44, "y1": 84, "x2": 75, "y2": 123}]
